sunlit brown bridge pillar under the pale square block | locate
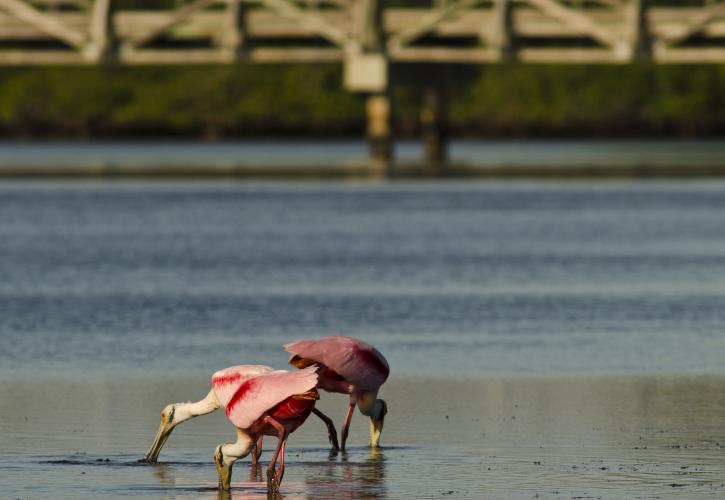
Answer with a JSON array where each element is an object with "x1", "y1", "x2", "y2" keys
[{"x1": 367, "y1": 92, "x2": 393, "y2": 177}]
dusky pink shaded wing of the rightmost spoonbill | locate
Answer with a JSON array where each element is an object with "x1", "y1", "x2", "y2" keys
[{"x1": 283, "y1": 335, "x2": 390, "y2": 390}]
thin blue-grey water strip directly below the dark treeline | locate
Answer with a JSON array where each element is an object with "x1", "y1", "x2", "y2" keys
[{"x1": 0, "y1": 140, "x2": 725, "y2": 172}]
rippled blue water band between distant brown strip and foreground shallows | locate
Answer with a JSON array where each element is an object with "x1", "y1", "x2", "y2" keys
[{"x1": 0, "y1": 182, "x2": 725, "y2": 376}]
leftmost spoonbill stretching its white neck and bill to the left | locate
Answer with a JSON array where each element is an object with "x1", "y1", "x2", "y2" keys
[{"x1": 143, "y1": 365, "x2": 338, "y2": 465}]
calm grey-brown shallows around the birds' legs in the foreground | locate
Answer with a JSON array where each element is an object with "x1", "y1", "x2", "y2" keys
[{"x1": 0, "y1": 375, "x2": 725, "y2": 499}]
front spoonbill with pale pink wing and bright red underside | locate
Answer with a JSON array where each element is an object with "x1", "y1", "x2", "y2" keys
[{"x1": 214, "y1": 366, "x2": 320, "y2": 493}]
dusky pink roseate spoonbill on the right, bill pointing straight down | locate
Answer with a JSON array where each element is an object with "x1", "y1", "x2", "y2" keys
[{"x1": 282, "y1": 335, "x2": 390, "y2": 451}]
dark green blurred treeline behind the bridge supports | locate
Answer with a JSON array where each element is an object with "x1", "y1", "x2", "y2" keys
[{"x1": 0, "y1": 64, "x2": 725, "y2": 138}]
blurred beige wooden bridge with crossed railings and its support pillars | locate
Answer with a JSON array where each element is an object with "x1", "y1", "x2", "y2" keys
[{"x1": 0, "y1": 0, "x2": 725, "y2": 168}]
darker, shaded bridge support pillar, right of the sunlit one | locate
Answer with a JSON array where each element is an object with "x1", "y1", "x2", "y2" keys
[{"x1": 420, "y1": 87, "x2": 448, "y2": 175}]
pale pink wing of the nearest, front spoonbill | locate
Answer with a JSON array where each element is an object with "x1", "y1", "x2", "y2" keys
[{"x1": 226, "y1": 366, "x2": 317, "y2": 429}]
